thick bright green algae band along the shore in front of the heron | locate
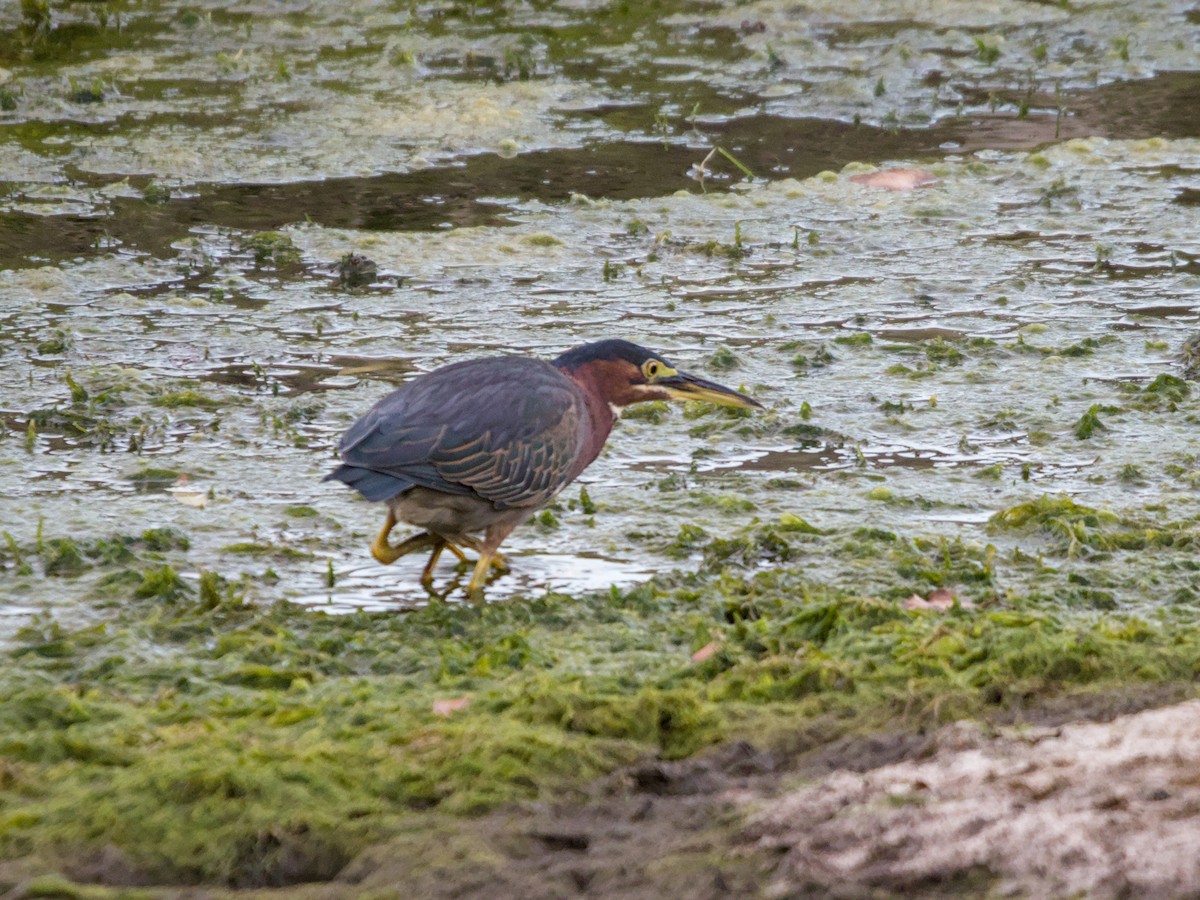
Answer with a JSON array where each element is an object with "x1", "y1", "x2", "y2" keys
[{"x1": 0, "y1": 542, "x2": 1200, "y2": 887}]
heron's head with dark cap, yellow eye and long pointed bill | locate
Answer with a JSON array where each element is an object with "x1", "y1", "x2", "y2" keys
[{"x1": 552, "y1": 341, "x2": 762, "y2": 409}]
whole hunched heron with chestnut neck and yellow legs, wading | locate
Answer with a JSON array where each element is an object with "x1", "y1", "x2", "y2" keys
[{"x1": 325, "y1": 341, "x2": 762, "y2": 594}]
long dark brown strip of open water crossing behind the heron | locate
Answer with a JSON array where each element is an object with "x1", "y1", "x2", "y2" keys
[{"x1": 7, "y1": 73, "x2": 1200, "y2": 268}]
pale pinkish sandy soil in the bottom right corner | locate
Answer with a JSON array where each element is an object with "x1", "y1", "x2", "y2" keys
[{"x1": 751, "y1": 701, "x2": 1200, "y2": 898}]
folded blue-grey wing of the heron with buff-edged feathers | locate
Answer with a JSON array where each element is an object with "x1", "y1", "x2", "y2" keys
[{"x1": 340, "y1": 356, "x2": 587, "y2": 509}]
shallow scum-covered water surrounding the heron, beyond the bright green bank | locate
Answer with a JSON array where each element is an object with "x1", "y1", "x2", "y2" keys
[{"x1": 0, "y1": 2, "x2": 1200, "y2": 617}]
